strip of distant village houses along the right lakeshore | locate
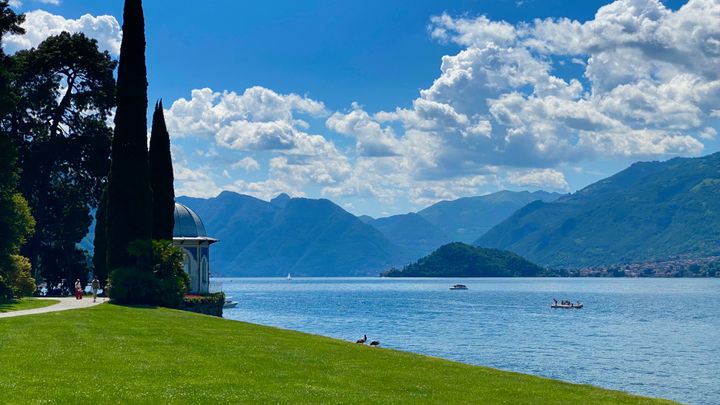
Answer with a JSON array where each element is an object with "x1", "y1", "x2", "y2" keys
[{"x1": 568, "y1": 256, "x2": 720, "y2": 277}]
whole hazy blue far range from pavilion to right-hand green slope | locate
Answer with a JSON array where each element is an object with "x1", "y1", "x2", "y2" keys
[{"x1": 177, "y1": 191, "x2": 560, "y2": 276}]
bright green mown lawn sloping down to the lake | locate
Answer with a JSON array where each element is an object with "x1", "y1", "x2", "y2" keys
[{"x1": 0, "y1": 304, "x2": 670, "y2": 404}]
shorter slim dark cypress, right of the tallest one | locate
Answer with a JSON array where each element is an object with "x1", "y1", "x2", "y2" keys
[{"x1": 150, "y1": 100, "x2": 175, "y2": 240}]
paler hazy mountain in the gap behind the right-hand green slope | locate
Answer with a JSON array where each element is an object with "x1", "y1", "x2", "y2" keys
[{"x1": 416, "y1": 191, "x2": 561, "y2": 246}]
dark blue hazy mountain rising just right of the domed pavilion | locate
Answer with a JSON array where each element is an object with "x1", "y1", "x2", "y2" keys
[{"x1": 178, "y1": 191, "x2": 408, "y2": 276}]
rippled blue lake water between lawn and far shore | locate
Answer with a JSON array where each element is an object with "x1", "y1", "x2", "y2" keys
[{"x1": 216, "y1": 278, "x2": 720, "y2": 404}]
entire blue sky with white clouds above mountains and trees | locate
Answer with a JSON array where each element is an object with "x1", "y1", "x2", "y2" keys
[{"x1": 3, "y1": 0, "x2": 720, "y2": 217}]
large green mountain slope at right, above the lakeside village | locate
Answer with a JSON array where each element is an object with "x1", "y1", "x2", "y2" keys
[{"x1": 475, "y1": 153, "x2": 720, "y2": 268}]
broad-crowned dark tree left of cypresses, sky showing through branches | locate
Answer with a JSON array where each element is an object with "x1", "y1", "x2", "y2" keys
[{"x1": 7, "y1": 32, "x2": 116, "y2": 281}]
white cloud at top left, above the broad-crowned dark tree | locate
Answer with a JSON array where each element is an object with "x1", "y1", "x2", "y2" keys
[{"x1": 3, "y1": 10, "x2": 122, "y2": 56}]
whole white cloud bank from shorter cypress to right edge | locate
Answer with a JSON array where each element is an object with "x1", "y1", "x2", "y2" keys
[{"x1": 166, "y1": 0, "x2": 720, "y2": 210}]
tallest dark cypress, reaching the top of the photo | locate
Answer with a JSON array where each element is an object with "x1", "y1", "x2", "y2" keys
[{"x1": 107, "y1": 0, "x2": 152, "y2": 271}]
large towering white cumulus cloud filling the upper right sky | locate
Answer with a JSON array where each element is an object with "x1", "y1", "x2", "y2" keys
[{"x1": 400, "y1": 0, "x2": 720, "y2": 172}]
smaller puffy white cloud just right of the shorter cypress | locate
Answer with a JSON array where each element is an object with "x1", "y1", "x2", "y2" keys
[{"x1": 165, "y1": 87, "x2": 351, "y2": 197}]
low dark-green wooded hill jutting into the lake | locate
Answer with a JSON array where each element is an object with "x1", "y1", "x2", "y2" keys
[{"x1": 383, "y1": 242, "x2": 550, "y2": 277}]
